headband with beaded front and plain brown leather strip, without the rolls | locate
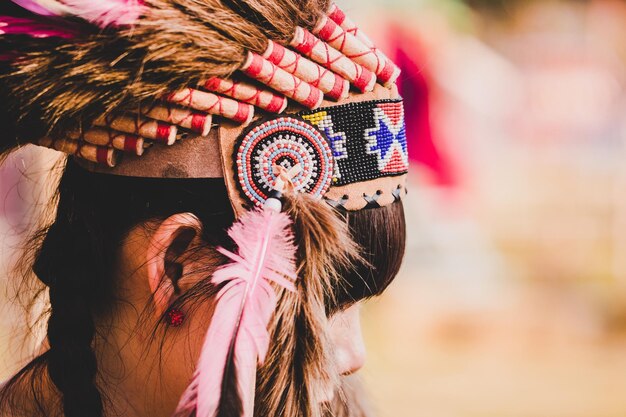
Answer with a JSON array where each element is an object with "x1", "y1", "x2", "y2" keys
[{"x1": 77, "y1": 86, "x2": 408, "y2": 213}]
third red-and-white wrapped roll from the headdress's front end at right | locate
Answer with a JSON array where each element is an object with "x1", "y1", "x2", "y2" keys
[{"x1": 290, "y1": 27, "x2": 376, "y2": 92}]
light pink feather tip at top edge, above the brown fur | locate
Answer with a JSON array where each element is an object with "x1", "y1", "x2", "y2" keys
[{"x1": 63, "y1": 0, "x2": 144, "y2": 28}]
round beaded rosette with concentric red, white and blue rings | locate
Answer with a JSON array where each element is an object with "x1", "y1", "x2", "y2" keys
[{"x1": 235, "y1": 116, "x2": 334, "y2": 206}]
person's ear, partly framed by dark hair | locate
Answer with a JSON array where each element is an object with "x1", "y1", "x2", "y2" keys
[{"x1": 146, "y1": 213, "x2": 202, "y2": 317}]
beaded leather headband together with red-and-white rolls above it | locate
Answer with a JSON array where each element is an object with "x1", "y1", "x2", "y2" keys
[{"x1": 31, "y1": 4, "x2": 408, "y2": 212}]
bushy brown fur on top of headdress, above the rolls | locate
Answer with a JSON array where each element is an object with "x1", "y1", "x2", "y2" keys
[{"x1": 0, "y1": 0, "x2": 327, "y2": 145}]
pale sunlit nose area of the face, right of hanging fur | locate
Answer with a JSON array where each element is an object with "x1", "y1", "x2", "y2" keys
[{"x1": 331, "y1": 304, "x2": 366, "y2": 375}]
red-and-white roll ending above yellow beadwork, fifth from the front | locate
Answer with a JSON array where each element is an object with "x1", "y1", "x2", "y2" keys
[{"x1": 241, "y1": 52, "x2": 324, "y2": 109}]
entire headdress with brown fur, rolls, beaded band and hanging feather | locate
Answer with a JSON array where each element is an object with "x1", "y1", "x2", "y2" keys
[{"x1": 0, "y1": 0, "x2": 408, "y2": 417}]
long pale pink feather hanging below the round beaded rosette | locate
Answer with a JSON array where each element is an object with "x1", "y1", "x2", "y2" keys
[{"x1": 174, "y1": 210, "x2": 297, "y2": 417}]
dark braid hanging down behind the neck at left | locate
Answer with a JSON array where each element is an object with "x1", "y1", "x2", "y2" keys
[{"x1": 35, "y1": 224, "x2": 104, "y2": 417}]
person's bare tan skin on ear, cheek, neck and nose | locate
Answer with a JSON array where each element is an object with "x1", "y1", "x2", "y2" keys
[{"x1": 0, "y1": 213, "x2": 365, "y2": 417}]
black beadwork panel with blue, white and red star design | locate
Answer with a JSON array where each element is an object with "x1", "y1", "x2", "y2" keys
[{"x1": 298, "y1": 99, "x2": 409, "y2": 186}]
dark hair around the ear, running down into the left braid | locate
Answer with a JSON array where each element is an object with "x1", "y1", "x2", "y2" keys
[{"x1": 0, "y1": 161, "x2": 233, "y2": 417}]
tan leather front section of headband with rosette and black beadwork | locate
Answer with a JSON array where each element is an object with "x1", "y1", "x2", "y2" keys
[{"x1": 220, "y1": 86, "x2": 408, "y2": 211}]
